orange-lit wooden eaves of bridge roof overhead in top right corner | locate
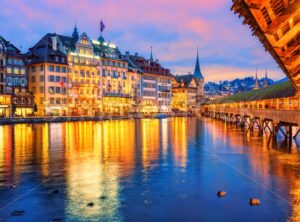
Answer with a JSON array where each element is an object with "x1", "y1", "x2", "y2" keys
[{"x1": 231, "y1": 0, "x2": 300, "y2": 90}]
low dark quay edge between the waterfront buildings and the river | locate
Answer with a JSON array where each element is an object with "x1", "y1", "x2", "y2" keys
[{"x1": 0, "y1": 113, "x2": 194, "y2": 125}]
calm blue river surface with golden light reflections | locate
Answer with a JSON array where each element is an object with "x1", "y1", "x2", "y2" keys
[{"x1": 0, "y1": 118, "x2": 300, "y2": 222}]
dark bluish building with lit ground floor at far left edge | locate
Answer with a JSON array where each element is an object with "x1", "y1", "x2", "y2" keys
[{"x1": 0, "y1": 36, "x2": 34, "y2": 117}]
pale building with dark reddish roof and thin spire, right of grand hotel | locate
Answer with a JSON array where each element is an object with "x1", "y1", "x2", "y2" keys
[{"x1": 126, "y1": 51, "x2": 173, "y2": 113}]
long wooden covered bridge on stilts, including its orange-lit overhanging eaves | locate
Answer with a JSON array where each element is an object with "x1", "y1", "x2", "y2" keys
[{"x1": 201, "y1": 0, "x2": 300, "y2": 139}]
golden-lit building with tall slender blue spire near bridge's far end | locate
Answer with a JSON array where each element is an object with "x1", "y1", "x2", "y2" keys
[{"x1": 172, "y1": 51, "x2": 204, "y2": 113}]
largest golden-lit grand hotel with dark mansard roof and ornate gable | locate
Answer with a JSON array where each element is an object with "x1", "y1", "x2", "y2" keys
[{"x1": 29, "y1": 26, "x2": 144, "y2": 116}]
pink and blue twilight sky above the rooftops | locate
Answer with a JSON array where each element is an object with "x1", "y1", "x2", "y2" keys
[{"x1": 0, "y1": 0, "x2": 285, "y2": 82}]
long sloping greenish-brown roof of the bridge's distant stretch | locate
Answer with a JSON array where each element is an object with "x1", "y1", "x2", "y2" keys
[{"x1": 207, "y1": 82, "x2": 297, "y2": 104}]
